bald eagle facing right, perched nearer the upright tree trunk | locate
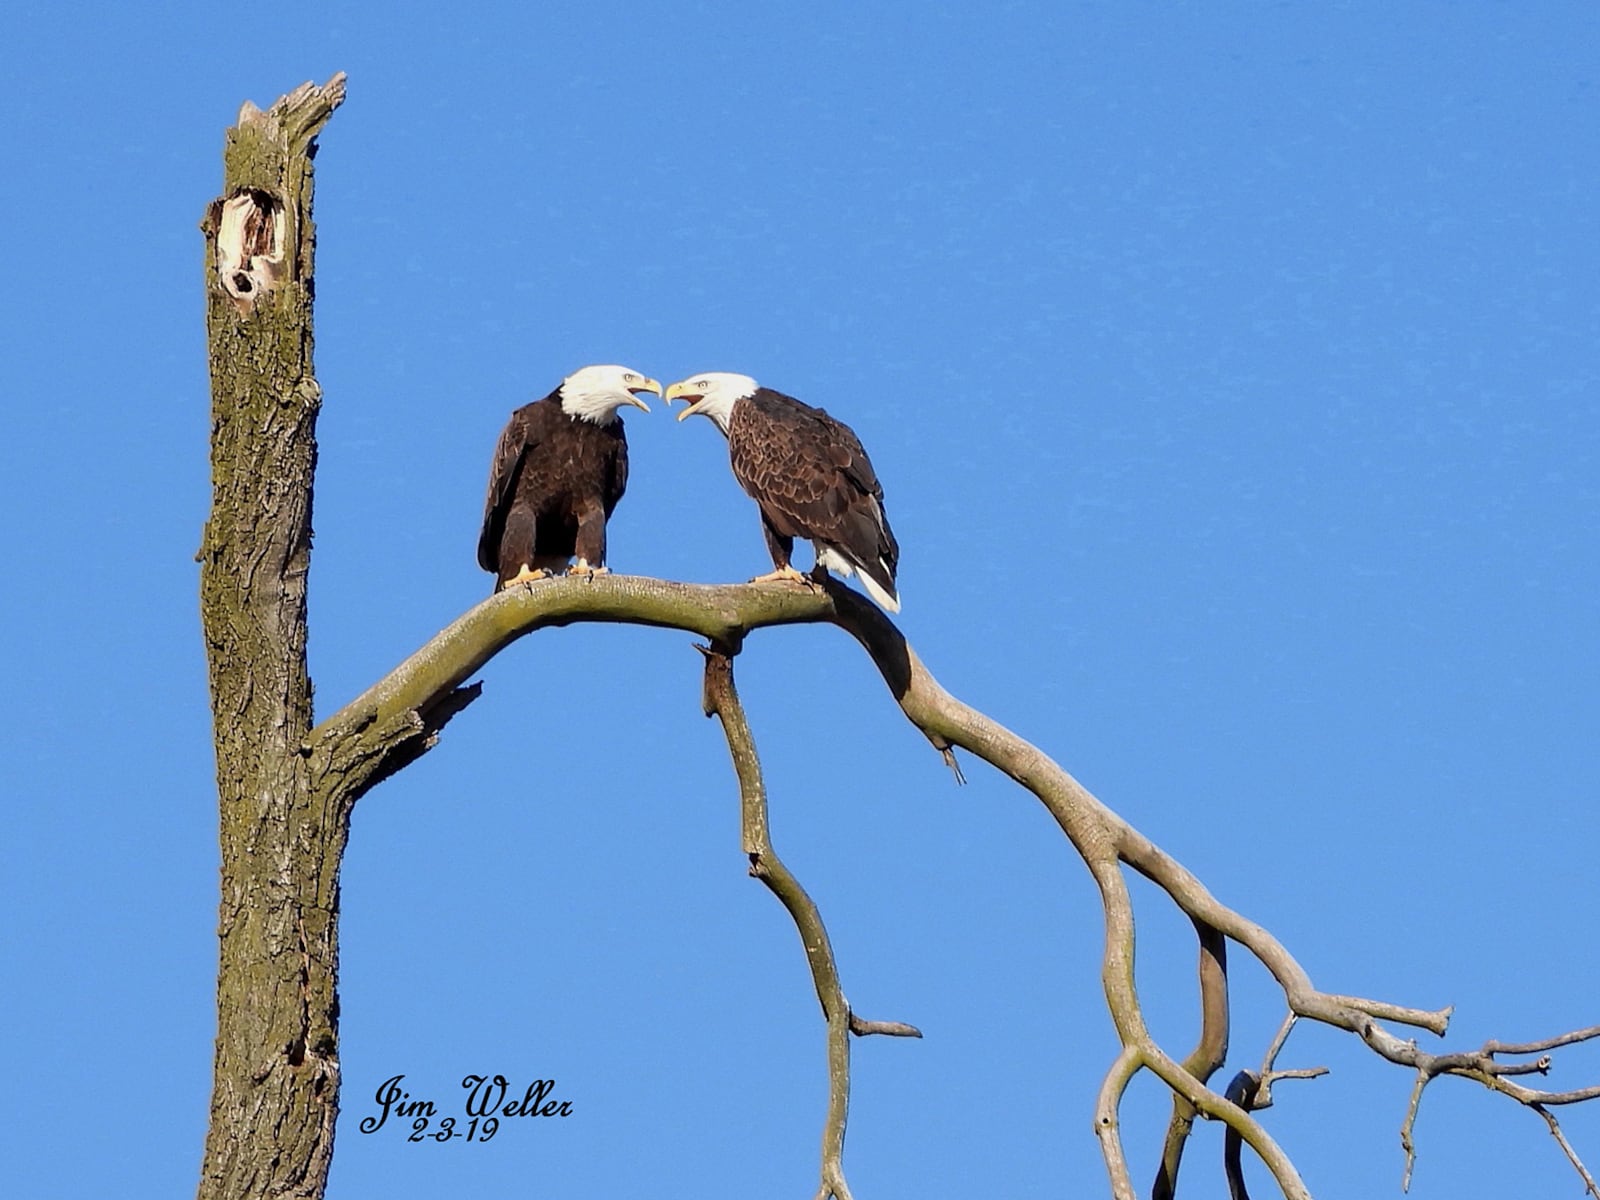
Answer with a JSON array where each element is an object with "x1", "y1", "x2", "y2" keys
[{"x1": 478, "y1": 366, "x2": 661, "y2": 590}]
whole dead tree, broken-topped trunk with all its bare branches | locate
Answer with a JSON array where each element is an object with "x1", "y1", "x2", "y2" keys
[{"x1": 198, "y1": 75, "x2": 1600, "y2": 1200}]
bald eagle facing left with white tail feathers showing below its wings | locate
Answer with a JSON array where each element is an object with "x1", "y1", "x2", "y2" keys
[{"x1": 664, "y1": 371, "x2": 899, "y2": 613}]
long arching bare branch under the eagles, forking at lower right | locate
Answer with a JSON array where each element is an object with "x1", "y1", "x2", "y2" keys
[{"x1": 302, "y1": 576, "x2": 1600, "y2": 1198}]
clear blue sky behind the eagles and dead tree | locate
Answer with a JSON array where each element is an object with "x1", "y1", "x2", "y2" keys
[{"x1": 0, "y1": 0, "x2": 1600, "y2": 1200}]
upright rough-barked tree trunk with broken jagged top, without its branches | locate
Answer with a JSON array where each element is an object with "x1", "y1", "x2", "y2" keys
[{"x1": 198, "y1": 75, "x2": 349, "y2": 1200}]
